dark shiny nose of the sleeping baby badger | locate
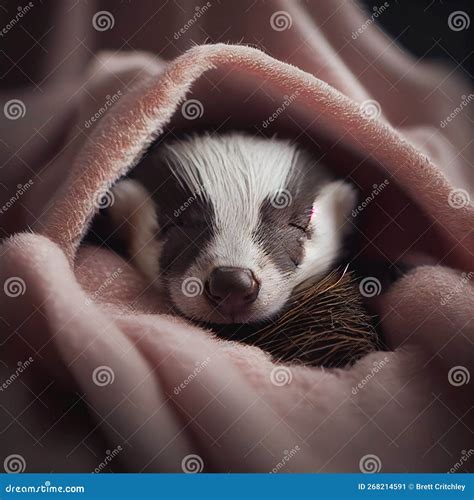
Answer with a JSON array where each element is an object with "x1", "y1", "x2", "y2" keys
[{"x1": 206, "y1": 267, "x2": 259, "y2": 313}]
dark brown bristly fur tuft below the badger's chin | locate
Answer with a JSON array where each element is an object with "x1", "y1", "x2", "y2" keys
[{"x1": 213, "y1": 270, "x2": 381, "y2": 367}]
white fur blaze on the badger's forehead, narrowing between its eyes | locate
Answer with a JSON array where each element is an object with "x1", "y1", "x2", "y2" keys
[{"x1": 161, "y1": 134, "x2": 300, "y2": 223}]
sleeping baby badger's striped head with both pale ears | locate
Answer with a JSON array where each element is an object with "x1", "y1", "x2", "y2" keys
[{"x1": 103, "y1": 133, "x2": 356, "y2": 323}]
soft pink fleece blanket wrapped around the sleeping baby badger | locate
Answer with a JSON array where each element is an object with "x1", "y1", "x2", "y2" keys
[{"x1": 0, "y1": 1, "x2": 474, "y2": 472}]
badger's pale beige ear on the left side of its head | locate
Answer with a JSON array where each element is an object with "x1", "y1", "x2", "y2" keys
[{"x1": 107, "y1": 179, "x2": 161, "y2": 279}]
